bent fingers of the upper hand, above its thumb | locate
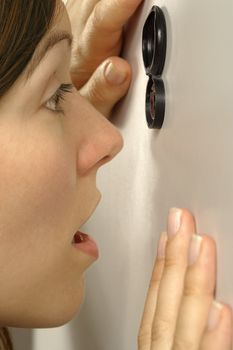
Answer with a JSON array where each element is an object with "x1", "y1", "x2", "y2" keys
[{"x1": 68, "y1": 0, "x2": 142, "y2": 89}]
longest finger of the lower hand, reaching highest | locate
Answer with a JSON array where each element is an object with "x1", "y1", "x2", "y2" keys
[{"x1": 151, "y1": 209, "x2": 196, "y2": 350}]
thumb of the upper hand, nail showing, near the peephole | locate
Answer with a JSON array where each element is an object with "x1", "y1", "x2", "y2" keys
[{"x1": 79, "y1": 57, "x2": 132, "y2": 118}]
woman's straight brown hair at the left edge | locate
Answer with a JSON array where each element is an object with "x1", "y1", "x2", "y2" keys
[{"x1": 0, "y1": 0, "x2": 59, "y2": 350}]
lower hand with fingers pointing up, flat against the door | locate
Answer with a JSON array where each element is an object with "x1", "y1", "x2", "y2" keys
[{"x1": 138, "y1": 209, "x2": 232, "y2": 350}]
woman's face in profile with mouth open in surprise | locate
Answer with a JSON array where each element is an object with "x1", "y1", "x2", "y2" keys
[{"x1": 0, "y1": 2, "x2": 123, "y2": 328}]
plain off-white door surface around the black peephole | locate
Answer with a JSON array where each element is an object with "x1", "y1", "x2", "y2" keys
[{"x1": 10, "y1": 0, "x2": 233, "y2": 350}]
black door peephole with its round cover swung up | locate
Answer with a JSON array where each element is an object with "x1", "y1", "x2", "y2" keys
[{"x1": 142, "y1": 6, "x2": 167, "y2": 129}]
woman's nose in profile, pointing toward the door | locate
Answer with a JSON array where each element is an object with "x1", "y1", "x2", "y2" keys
[{"x1": 74, "y1": 95, "x2": 124, "y2": 175}]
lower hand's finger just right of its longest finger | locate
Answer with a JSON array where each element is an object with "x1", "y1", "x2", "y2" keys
[{"x1": 173, "y1": 235, "x2": 217, "y2": 350}]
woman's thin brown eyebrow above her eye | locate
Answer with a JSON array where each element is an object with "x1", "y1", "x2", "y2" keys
[{"x1": 26, "y1": 31, "x2": 74, "y2": 80}]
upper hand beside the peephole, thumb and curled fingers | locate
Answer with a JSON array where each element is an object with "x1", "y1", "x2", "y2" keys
[{"x1": 66, "y1": 0, "x2": 142, "y2": 117}]
